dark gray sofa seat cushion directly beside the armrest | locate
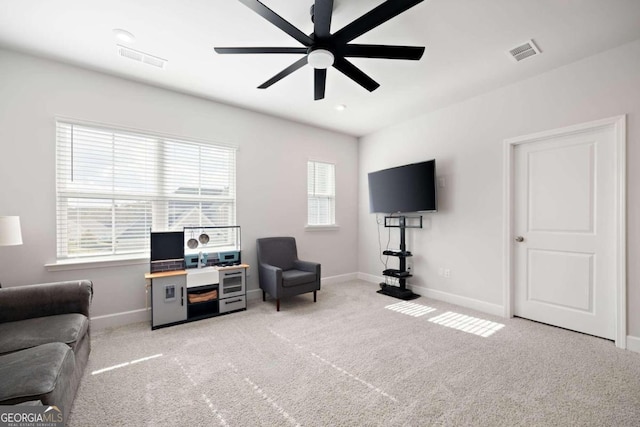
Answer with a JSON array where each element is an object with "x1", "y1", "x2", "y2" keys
[{"x1": 0, "y1": 313, "x2": 89, "y2": 354}]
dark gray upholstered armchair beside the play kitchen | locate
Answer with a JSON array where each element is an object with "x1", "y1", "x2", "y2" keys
[{"x1": 256, "y1": 237, "x2": 320, "y2": 311}]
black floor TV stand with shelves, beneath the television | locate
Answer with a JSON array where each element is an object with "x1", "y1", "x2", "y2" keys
[{"x1": 377, "y1": 216, "x2": 422, "y2": 301}]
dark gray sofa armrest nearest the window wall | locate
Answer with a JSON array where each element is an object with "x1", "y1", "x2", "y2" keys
[{"x1": 0, "y1": 280, "x2": 93, "y2": 323}]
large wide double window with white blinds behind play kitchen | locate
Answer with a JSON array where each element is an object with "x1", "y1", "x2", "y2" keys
[{"x1": 56, "y1": 121, "x2": 236, "y2": 259}]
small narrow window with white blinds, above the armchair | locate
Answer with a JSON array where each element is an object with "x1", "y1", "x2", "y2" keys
[{"x1": 307, "y1": 161, "x2": 336, "y2": 225}]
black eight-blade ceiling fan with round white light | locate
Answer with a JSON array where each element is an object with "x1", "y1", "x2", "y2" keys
[{"x1": 214, "y1": 0, "x2": 424, "y2": 101}]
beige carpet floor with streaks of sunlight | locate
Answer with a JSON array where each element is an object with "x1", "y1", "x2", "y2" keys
[{"x1": 68, "y1": 281, "x2": 640, "y2": 427}]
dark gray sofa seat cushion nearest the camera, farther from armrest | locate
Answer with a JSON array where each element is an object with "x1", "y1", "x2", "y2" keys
[{"x1": 0, "y1": 342, "x2": 75, "y2": 405}]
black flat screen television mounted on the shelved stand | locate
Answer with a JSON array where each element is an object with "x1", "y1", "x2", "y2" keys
[{"x1": 369, "y1": 160, "x2": 438, "y2": 214}]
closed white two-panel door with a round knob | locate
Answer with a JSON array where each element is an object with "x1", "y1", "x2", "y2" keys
[{"x1": 512, "y1": 121, "x2": 618, "y2": 339}]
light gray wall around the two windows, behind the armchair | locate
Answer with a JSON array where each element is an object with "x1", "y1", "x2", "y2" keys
[{"x1": 0, "y1": 46, "x2": 358, "y2": 328}]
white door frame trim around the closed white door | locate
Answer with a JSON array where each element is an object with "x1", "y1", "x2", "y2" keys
[{"x1": 503, "y1": 115, "x2": 627, "y2": 348}]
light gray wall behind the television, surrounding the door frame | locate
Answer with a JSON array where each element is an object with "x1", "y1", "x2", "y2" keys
[{"x1": 358, "y1": 41, "x2": 640, "y2": 351}]
